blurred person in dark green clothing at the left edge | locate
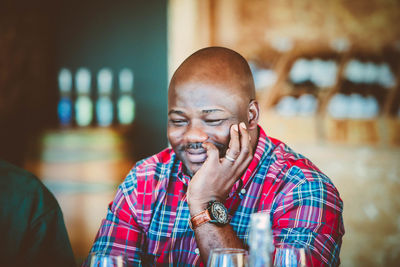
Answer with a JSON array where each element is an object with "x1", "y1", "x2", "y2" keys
[{"x1": 0, "y1": 160, "x2": 76, "y2": 267}]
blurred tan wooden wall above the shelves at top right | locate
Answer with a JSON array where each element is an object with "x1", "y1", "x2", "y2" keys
[{"x1": 211, "y1": 0, "x2": 400, "y2": 55}]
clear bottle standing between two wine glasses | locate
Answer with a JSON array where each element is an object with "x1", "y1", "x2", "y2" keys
[{"x1": 249, "y1": 212, "x2": 274, "y2": 267}]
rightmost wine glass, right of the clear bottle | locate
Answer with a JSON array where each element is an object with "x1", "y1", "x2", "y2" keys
[{"x1": 274, "y1": 245, "x2": 312, "y2": 267}]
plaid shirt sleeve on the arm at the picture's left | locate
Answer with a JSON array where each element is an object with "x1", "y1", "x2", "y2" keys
[{"x1": 84, "y1": 164, "x2": 151, "y2": 266}]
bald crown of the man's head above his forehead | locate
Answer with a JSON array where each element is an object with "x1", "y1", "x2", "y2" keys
[{"x1": 169, "y1": 47, "x2": 255, "y2": 100}]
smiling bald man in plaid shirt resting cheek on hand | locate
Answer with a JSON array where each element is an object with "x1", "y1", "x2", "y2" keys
[{"x1": 87, "y1": 47, "x2": 344, "y2": 266}]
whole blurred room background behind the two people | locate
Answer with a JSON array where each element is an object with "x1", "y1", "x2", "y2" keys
[{"x1": 0, "y1": 0, "x2": 400, "y2": 266}]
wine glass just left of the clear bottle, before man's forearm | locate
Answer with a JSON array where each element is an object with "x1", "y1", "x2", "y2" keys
[{"x1": 207, "y1": 248, "x2": 248, "y2": 267}]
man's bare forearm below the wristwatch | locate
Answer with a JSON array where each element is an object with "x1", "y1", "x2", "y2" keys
[{"x1": 194, "y1": 222, "x2": 244, "y2": 263}]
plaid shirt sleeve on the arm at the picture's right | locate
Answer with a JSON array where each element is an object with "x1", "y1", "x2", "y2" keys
[{"x1": 272, "y1": 166, "x2": 344, "y2": 266}]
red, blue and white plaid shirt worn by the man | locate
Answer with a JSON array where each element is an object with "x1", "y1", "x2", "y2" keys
[{"x1": 87, "y1": 127, "x2": 344, "y2": 266}]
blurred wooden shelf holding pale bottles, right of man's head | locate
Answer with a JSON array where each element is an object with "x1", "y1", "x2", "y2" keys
[{"x1": 253, "y1": 47, "x2": 400, "y2": 146}]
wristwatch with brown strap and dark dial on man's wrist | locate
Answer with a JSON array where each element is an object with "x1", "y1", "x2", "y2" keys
[{"x1": 189, "y1": 200, "x2": 229, "y2": 230}]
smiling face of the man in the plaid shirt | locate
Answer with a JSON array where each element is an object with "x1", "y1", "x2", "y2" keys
[{"x1": 168, "y1": 79, "x2": 248, "y2": 175}]
